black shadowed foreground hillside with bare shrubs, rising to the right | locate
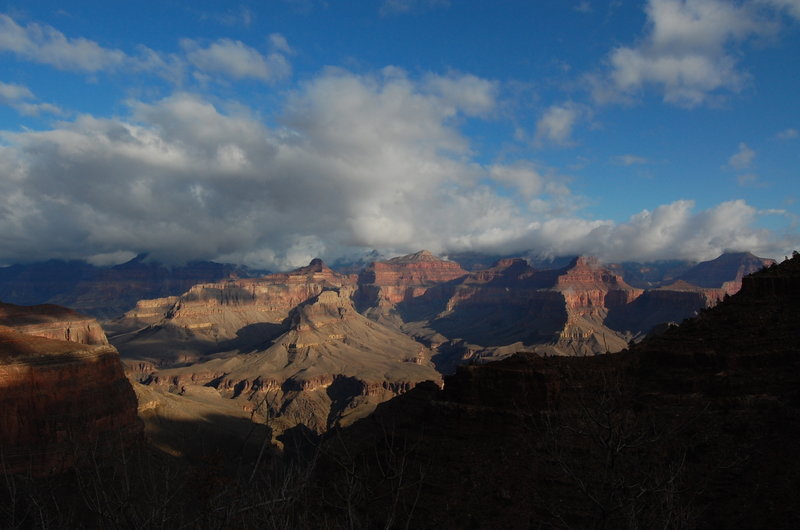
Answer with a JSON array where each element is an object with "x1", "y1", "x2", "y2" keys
[{"x1": 0, "y1": 255, "x2": 800, "y2": 528}]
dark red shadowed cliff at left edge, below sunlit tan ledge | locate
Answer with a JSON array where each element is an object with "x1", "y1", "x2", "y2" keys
[{"x1": 0, "y1": 326, "x2": 142, "y2": 475}]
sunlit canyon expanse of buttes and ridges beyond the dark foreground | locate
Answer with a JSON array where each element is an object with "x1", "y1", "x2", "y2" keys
[{"x1": 106, "y1": 251, "x2": 770, "y2": 442}]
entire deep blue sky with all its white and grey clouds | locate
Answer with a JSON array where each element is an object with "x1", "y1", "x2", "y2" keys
[{"x1": 0, "y1": 0, "x2": 800, "y2": 268}]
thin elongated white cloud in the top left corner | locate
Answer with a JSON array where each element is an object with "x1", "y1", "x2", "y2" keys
[{"x1": 0, "y1": 15, "x2": 126, "y2": 72}]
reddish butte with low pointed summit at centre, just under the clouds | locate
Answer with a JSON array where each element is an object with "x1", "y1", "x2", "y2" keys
[{"x1": 356, "y1": 250, "x2": 467, "y2": 308}]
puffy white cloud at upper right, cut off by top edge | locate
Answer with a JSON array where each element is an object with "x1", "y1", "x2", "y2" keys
[{"x1": 591, "y1": 0, "x2": 772, "y2": 107}]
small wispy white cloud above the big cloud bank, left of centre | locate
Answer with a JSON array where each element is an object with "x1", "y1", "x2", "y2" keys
[{"x1": 181, "y1": 39, "x2": 292, "y2": 82}]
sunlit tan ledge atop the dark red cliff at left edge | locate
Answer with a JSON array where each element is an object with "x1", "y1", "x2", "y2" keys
[{"x1": 0, "y1": 302, "x2": 108, "y2": 345}]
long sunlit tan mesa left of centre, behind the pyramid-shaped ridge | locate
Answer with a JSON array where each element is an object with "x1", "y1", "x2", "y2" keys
[{"x1": 110, "y1": 259, "x2": 355, "y2": 362}]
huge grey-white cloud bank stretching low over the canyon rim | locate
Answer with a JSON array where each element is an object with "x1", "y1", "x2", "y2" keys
[{"x1": 0, "y1": 69, "x2": 791, "y2": 269}]
